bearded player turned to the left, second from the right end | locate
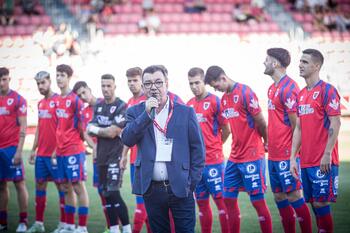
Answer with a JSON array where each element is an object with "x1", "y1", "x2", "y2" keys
[{"x1": 264, "y1": 48, "x2": 312, "y2": 233}]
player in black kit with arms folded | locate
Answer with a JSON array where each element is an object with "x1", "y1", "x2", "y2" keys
[{"x1": 87, "y1": 74, "x2": 131, "y2": 233}]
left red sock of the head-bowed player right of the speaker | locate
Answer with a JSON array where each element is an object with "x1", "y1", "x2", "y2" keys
[{"x1": 224, "y1": 198, "x2": 241, "y2": 233}]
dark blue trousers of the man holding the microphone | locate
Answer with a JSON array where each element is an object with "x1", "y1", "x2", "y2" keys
[{"x1": 143, "y1": 181, "x2": 196, "y2": 233}]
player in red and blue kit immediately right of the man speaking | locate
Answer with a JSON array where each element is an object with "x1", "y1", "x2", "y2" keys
[{"x1": 187, "y1": 67, "x2": 231, "y2": 233}]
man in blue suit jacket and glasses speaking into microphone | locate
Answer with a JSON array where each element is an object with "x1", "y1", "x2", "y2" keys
[{"x1": 122, "y1": 66, "x2": 205, "y2": 233}]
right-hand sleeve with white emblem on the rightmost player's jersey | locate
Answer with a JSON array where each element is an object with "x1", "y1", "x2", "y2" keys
[{"x1": 323, "y1": 84, "x2": 341, "y2": 116}]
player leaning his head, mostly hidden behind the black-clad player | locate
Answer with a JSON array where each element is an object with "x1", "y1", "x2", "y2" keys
[{"x1": 73, "y1": 81, "x2": 109, "y2": 232}]
